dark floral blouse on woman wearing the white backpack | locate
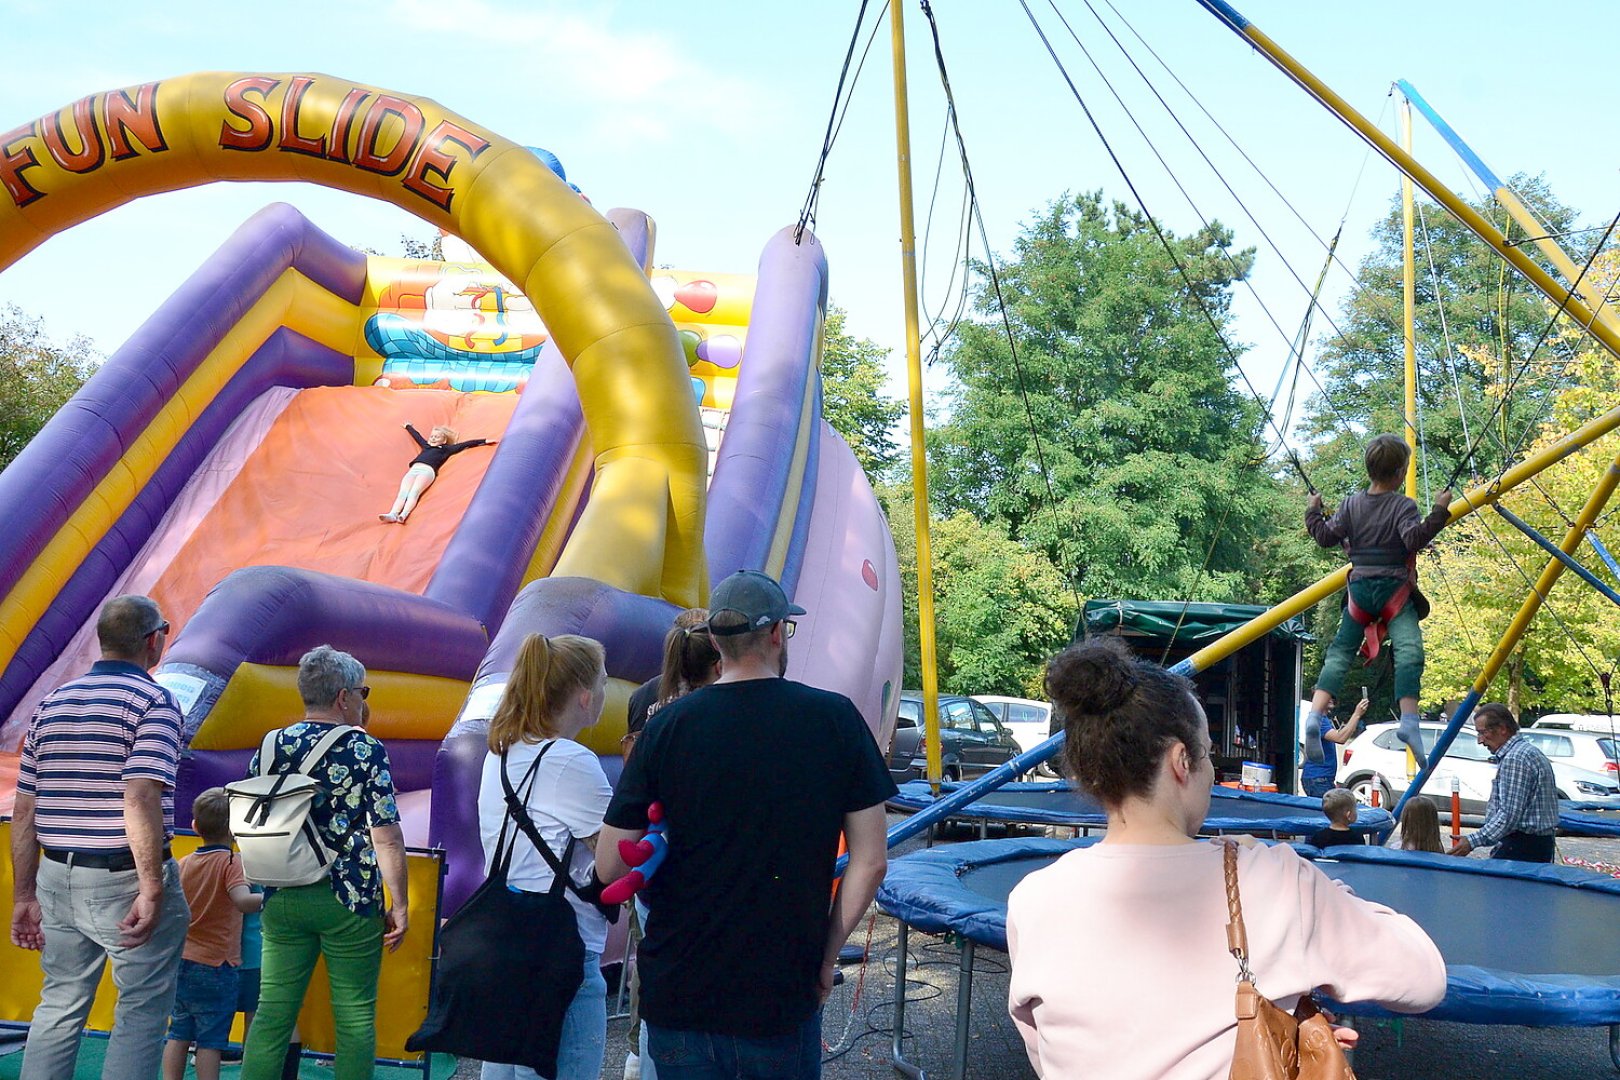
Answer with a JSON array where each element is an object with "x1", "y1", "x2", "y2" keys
[{"x1": 248, "y1": 721, "x2": 400, "y2": 916}]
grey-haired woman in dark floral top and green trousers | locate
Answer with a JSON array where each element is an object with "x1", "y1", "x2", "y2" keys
[{"x1": 241, "y1": 644, "x2": 407, "y2": 1080}]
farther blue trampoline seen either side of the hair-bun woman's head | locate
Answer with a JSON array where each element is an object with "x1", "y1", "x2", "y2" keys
[{"x1": 889, "y1": 780, "x2": 1393, "y2": 839}]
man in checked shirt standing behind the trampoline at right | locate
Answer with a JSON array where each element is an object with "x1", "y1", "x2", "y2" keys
[{"x1": 1452, "y1": 703, "x2": 1558, "y2": 863}]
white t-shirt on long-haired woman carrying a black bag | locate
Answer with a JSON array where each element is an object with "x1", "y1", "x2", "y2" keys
[{"x1": 478, "y1": 738, "x2": 612, "y2": 952}]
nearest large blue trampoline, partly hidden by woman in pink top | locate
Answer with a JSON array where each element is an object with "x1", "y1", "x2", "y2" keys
[{"x1": 878, "y1": 837, "x2": 1620, "y2": 1077}]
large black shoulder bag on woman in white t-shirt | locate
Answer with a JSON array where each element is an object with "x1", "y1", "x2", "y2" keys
[{"x1": 405, "y1": 743, "x2": 585, "y2": 1077}]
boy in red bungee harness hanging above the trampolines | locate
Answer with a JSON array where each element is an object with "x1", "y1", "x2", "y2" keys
[{"x1": 1306, "y1": 436, "x2": 1452, "y2": 767}]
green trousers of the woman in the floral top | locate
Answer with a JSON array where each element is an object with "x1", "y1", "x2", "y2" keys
[{"x1": 241, "y1": 881, "x2": 382, "y2": 1080}]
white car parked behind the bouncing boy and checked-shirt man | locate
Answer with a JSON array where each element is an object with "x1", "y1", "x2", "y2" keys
[{"x1": 1338, "y1": 724, "x2": 1620, "y2": 814}]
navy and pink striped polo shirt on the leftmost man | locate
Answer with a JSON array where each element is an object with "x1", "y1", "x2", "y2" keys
[{"x1": 16, "y1": 661, "x2": 180, "y2": 852}]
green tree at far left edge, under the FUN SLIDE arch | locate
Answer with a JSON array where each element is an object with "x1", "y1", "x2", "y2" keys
[{"x1": 0, "y1": 304, "x2": 102, "y2": 468}]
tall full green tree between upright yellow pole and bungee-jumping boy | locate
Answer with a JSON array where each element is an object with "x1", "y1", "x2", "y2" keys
[{"x1": 928, "y1": 194, "x2": 1278, "y2": 601}]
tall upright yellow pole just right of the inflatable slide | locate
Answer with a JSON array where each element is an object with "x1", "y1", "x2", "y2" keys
[{"x1": 889, "y1": 3, "x2": 941, "y2": 795}]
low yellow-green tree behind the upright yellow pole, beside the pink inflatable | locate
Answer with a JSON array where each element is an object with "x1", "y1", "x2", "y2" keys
[{"x1": 878, "y1": 484, "x2": 1077, "y2": 698}]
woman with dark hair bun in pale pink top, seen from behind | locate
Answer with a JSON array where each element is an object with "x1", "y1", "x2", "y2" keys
[{"x1": 1008, "y1": 638, "x2": 1445, "y2": 1080}]
